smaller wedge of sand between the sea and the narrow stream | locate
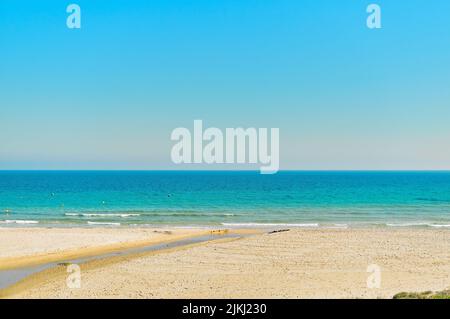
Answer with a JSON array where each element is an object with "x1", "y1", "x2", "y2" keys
[{"x1": 0, "y1": 228, "x2": 213, "y2": 270}]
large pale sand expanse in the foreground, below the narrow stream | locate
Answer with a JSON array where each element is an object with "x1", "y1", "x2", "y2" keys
[{"x1": 2, "y1": 229, "x2": 450, "y2": 298}]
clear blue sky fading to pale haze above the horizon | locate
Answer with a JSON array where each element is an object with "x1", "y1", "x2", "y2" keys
[{"x1": 0, "y1": 0, "x2": 450, "y2": 170}]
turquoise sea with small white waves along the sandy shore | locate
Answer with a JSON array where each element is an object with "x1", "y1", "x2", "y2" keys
[{"x1": 0, "y1": 171, "x2": 450, "y2": 229}]
